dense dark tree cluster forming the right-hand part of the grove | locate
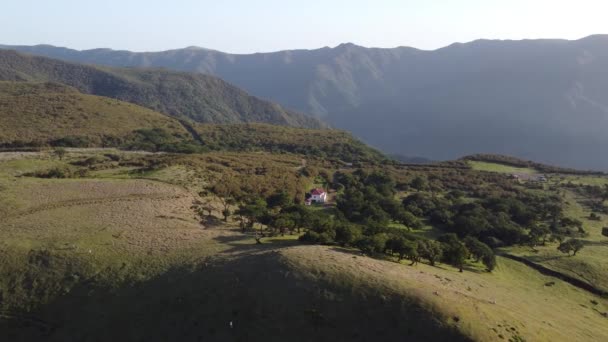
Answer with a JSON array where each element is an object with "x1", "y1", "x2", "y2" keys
[{"x1": 403, "y1": 190, "x2": 587, "y2": 251}]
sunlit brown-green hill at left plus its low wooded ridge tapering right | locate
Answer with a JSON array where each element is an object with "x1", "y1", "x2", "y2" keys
[{"x1": 0, "y1": 81, "x2": 384, "y2": 162}]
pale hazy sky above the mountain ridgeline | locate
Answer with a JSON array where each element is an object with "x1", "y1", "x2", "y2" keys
[{"x1": 0, "y1": 0, "x2": 608, "y2": 53}]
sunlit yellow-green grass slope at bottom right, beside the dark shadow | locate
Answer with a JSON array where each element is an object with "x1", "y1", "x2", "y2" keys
[{"x1": 284, "y1": 247, "x2": 608, "y2": 341}]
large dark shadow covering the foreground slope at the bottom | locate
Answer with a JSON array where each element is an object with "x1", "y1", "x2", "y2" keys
[{"x1": 0, "y1": 246, "x2": 468, "y2": 342}]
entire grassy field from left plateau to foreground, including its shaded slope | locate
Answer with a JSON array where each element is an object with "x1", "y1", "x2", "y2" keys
[{"x1": 0, "y1": 150, "x2": 608, "y2": 341}]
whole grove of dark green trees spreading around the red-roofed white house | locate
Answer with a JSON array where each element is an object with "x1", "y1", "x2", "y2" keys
[{"x1": 202, "y1": 162, "x2": 585, "y2": 271}]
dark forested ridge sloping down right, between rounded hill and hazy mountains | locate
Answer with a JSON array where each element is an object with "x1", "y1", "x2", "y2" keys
[{"x1": 0, "y1": 50, "x2": 325, "y2": 128}]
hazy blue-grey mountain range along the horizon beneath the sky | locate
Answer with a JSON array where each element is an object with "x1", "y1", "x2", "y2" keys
[{"x1": 5, "y1": 35, "x2": 608, "y2": 170}]
